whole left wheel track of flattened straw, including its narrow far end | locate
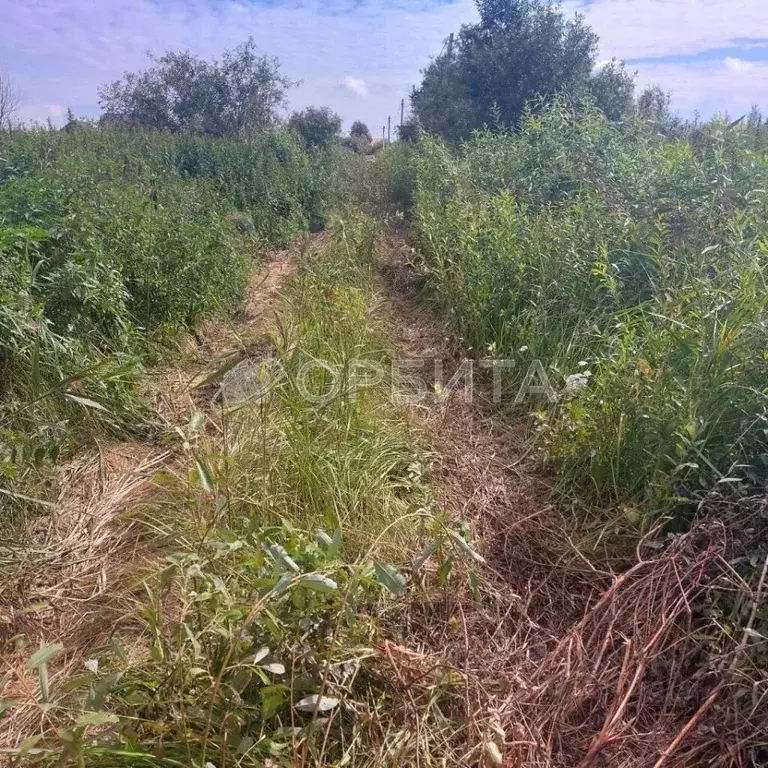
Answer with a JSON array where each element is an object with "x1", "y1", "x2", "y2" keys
[{"x1": 0, "y1": 253, "x2": 295, "y2": 752}]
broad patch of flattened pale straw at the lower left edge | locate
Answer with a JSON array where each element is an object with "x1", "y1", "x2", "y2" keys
[{"x1": 0, "y1": 443, "x2": 171, "y2": 747}]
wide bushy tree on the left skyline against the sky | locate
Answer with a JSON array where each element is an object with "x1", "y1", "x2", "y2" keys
[{"x1": 99, "y1": 38, "x2": 296, "y2": 136}]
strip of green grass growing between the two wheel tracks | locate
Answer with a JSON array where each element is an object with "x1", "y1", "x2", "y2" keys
[{"x1": 6, "y1": 211, "x2": 476, "y2": 767}]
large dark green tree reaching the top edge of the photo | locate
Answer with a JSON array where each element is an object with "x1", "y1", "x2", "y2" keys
[{"x1": 411, "y1": 0, "x2": 634, "y2": 140}]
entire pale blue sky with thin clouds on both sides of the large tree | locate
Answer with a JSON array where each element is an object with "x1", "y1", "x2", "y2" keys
[{"x1": 0, "y1": 0, "x2": 768, "y2": 130}]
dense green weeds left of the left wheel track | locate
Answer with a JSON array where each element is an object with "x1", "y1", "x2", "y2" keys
[{"x1": 0, "y1": 130, "x2": 338, "y2": 525}]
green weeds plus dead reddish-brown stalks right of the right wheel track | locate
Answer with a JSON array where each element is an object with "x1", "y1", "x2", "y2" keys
[{"x1": 397, "y1": 101, "x2": 768, "y2": 768}]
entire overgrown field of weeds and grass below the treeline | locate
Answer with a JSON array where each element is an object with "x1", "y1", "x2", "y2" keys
[{"x1": 0, "y1": 109, "x2": 768, "y2": 768}]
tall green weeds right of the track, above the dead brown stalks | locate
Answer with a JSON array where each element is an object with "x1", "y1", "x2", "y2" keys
[{"x1": 414, "y1": 97, "x2": 768, "y2": 517}]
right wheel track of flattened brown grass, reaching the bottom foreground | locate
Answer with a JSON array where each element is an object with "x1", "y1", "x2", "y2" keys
[{"x1": 380, "y1": 230, "x2": 578, "y2": 765}]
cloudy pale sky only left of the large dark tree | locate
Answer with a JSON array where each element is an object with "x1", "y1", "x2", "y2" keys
[{"x1": 0, "y1": 0, "x2": 476, "y2": 132}]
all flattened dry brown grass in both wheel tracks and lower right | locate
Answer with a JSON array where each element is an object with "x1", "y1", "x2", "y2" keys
[{"x1": 0, "y1": 230, "x2": 768, "y2": 768}]
